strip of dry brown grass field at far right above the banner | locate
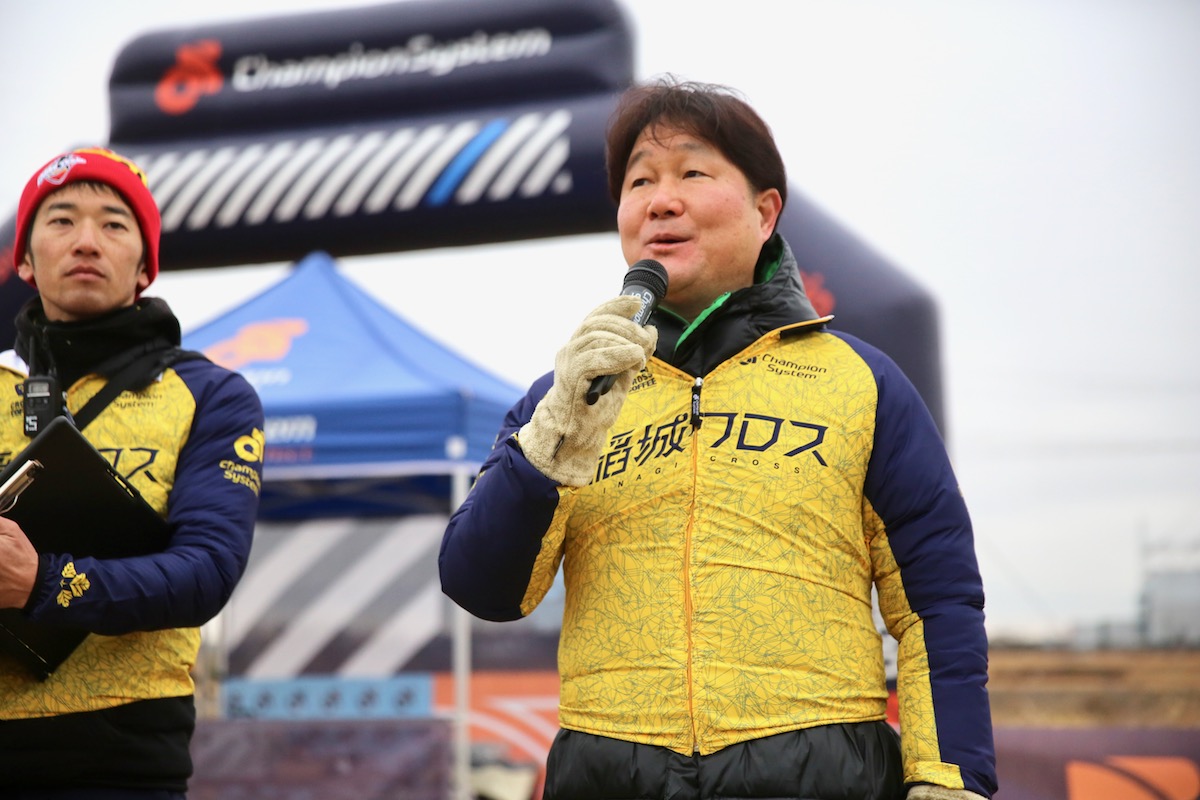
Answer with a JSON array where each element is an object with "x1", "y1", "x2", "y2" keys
[{"x1": 989, "y1": 648, "x2": 1200, "y2": 728}]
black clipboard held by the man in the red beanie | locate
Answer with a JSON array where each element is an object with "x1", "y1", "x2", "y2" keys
[{"x1": 0, "y1": 416, "x2": 170, "y2": 679}]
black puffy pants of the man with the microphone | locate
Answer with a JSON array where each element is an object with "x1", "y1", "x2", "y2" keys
[{"x1": 542, "y1": 722, "x2": 905, "y2": 800}]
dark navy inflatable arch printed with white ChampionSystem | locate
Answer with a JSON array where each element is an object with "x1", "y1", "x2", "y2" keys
[{"x1": 0, "y1": 0, "x2": 944, "y2": 429}]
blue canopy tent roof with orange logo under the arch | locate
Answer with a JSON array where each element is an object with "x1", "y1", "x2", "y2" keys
[{"x1": 184, "y1": 252, "x2": 521, "y2": 519}]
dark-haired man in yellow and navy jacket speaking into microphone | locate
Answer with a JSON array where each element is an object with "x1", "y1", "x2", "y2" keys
[{"x1": 439, "y1": 79, "x2": 996, "y2": 800}]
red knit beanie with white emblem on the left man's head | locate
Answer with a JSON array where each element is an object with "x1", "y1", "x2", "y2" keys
[{"x1": 12, "y1": 148, "x2": 162, "y2": 284}]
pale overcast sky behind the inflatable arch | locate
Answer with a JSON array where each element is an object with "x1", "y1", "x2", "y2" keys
[{"x1": 0, "y1": 0, "x2": 1200, "y2": 634}]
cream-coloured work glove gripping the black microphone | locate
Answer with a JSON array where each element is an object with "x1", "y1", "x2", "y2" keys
[{"x1": 517, "y1": 295, "x2": 659, "y2": 486}]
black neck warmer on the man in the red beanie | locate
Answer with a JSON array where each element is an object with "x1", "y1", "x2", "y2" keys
[{"x1": 13, "y1": 296, "x2": 182, "y2": 386}]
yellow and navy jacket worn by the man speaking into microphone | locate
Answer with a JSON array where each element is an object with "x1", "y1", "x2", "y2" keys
[{"x1": 440, "y1": 236, "x2": 996, "y2": 795}]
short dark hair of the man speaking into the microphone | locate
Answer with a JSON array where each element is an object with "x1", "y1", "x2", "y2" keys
[{"x1": 605, "y1": 76, "x2": 787, "y2": 204}]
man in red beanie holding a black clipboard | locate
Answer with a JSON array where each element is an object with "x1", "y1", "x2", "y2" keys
[{"x1": 0, "y1": 148, "x2": 263, "y2": 800}]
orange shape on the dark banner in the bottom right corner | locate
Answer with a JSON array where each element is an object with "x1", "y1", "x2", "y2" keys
[{"x1": 1067, "y1": 756, "x2": 1200, "y2": 800}]
